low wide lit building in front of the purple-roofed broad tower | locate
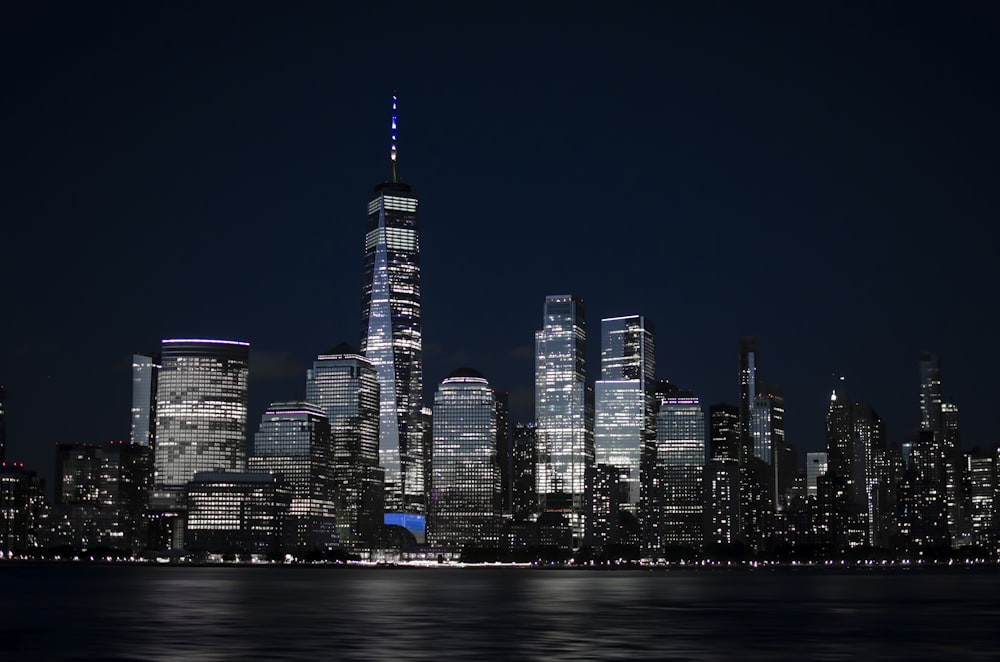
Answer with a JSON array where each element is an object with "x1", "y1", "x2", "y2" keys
[{"x1": 184, "y1": 471, "x2": 292, "y2": 557}]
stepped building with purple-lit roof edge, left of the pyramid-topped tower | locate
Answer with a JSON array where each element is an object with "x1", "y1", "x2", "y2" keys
[{"x1": 247, "y1": 402, "x2": 339, "y2": 550}]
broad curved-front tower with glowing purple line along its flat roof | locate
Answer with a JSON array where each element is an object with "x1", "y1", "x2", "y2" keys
[{"x1": 150, "y1": 338, "x2": 249, "y2": 547}]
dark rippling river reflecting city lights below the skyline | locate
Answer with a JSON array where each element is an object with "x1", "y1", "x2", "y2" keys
[{"x1": 0, "y1": 564, "x2": 1000, "y2": 661}]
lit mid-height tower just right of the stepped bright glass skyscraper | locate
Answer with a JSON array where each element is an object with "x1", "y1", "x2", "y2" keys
[{"x1": 651, "y1": 389, "x2": 705, "y2": 550}]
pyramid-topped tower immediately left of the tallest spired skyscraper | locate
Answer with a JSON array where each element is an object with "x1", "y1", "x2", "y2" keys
[{"x1": 306, "y1": 343, "x2": 384, "y2": 547}]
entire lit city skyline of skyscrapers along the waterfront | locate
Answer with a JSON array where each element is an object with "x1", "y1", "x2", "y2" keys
[{"x1": 0, "y1": 99, "x2": 998, "y2": 559}]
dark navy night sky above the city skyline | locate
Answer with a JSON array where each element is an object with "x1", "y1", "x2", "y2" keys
[{"x1": 0, "y1": 2, "x2": 1000, "y2": 486}]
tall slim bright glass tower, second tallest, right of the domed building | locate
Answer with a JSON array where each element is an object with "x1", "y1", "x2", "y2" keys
[{"x1": 535, "y1": 294, "x2": 594, "y2": 545}]
